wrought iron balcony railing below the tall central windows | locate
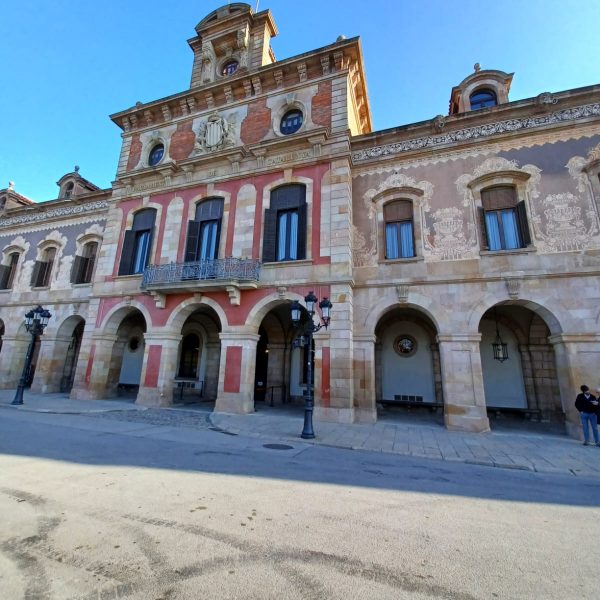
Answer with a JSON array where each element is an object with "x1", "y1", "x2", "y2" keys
[{"x1": 142, "y1": 258, "x2": 260, "y2": 288}]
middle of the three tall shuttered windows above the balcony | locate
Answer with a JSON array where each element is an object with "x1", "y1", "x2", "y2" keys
[{"x1": 184, "y1": 198, "x2": 223, "y2": 262}]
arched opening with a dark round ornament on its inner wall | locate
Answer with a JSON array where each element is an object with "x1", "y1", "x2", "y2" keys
[{"x1": 375, "y1": 308, "x2": 443, "y2": 423}]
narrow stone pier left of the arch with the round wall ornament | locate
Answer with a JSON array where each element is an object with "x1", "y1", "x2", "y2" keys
[{"x1": 354, "y1": 333, "x2": 377, "y2": 423}]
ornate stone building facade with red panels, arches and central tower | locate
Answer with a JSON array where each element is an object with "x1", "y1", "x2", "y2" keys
[{"x1": 0, "y1": 3, "x2": 600, "y2": 433}]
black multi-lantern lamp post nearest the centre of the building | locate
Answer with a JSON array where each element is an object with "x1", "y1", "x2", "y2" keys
[{"x1": 291, "y1": 292, "x2": 332, "y2": 439}]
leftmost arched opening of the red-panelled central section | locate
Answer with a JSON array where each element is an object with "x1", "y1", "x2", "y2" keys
[{"x1": 106, "y1": 308, "x2": 146, "y2": 398}]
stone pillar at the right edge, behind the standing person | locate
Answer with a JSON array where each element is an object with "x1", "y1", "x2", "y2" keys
[{"x1": 548, "y1": 333, "x2": 600, "y2": 439}]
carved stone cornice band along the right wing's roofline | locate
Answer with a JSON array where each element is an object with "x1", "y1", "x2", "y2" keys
[{"x1": 352, "y1": 103, "x2": 600, "y2": 163}]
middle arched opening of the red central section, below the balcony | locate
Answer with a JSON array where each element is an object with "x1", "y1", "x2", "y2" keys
[{"x1": 173, "y1": 305, "x2": 221, "y2": 403}]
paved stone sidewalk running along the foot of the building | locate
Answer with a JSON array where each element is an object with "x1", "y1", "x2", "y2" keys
[{"x1": 0, "y1": 390, "x2": 600, "y2": 478}]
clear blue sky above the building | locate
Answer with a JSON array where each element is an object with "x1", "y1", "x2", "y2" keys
[{"x1": 0, "y1": 0, "x2": 600, "y2": 201}]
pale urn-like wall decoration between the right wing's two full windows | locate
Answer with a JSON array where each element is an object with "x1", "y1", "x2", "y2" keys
[{"x1": 423, "y1": 207, "x2": 477, "y2": 260}]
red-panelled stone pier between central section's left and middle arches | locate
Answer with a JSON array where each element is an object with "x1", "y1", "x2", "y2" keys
[{"x1": 136, "y1": 332, "x2": 183, "y2": 406}]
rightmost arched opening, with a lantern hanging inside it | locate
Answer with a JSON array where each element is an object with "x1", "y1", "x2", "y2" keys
[{"x1": 479, "y1": 304, "x2": 565, "y2": 431}]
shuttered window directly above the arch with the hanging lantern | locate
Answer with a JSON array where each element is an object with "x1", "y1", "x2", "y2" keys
[{"x1": 479, "y1": 185, "x2": 531, "y2": 250}]
